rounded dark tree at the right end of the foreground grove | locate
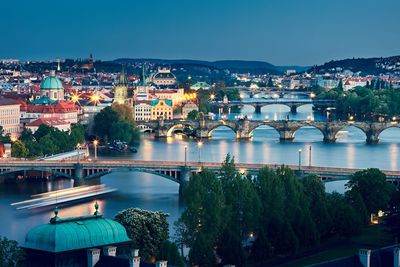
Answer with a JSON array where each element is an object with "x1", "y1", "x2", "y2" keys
[{"x1": 346, "y1": 169, "x2": 395, "y2": 214}]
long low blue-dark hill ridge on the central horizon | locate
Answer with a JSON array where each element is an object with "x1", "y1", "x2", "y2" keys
[{"x1": 114, "y1": 58, "x2": 282, "y2": 74}]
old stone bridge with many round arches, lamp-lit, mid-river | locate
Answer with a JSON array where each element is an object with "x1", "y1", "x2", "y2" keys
[{"x1": 137, "y1": 118, "x2": 400, "y2": 144}]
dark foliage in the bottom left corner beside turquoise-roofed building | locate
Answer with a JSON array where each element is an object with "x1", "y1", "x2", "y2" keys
[{"x1": 0, "y1": 236, "x2": 25, "y2": 267}]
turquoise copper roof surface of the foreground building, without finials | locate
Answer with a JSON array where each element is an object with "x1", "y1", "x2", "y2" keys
[{"x1": 23, "y1": 215, "x2": 131, "y2": 253}]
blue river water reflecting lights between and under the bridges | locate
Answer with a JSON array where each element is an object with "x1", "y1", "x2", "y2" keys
[{"x1": 0, "y1": 106, "x2": 400, "y2": 243}]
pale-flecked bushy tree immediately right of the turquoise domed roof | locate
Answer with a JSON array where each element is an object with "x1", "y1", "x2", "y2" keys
[{"x1": 114, "y1": 208, "x2": 169, "y2": 260}]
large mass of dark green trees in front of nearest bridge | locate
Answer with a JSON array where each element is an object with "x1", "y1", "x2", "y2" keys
[{"x1": 176, "y1": 158, "x2": 400, "y2": 266}]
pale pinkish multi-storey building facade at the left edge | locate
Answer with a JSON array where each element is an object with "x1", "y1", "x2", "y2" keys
[{"x1": 0, "y1": 98, "x2": 21, "y2": 137}]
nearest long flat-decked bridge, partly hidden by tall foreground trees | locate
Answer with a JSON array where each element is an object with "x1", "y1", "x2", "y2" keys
[{"x1": 0, "y1": 160, "x2": 400, "y2": 192}]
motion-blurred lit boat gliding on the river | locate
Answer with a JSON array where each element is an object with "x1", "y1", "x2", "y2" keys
[{"x1": 11, "y1": 184, "x2": 117, "y2": 210}]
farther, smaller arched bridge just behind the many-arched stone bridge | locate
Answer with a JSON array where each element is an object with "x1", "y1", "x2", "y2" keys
[{"x1": 209, "y1": 98, "x2": 335, "y2": 113}]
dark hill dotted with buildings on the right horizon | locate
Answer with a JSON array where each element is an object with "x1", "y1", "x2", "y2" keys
[{"x1": 316, "y1": 56, "x2": 400, "y2": 75}]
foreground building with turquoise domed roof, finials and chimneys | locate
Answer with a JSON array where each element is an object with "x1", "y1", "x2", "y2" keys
[{"x1": 22, "y1": 203, "x2": 136, "y2": 267}]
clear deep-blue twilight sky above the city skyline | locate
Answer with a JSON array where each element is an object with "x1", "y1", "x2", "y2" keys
[{"x1": 0, "y1": 0, "x2": 400, "y2": 65}]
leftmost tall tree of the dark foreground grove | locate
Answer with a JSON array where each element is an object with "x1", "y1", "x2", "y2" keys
[{"x1": 178, "y1": 169, "x2": 225, "y2": 266}]
